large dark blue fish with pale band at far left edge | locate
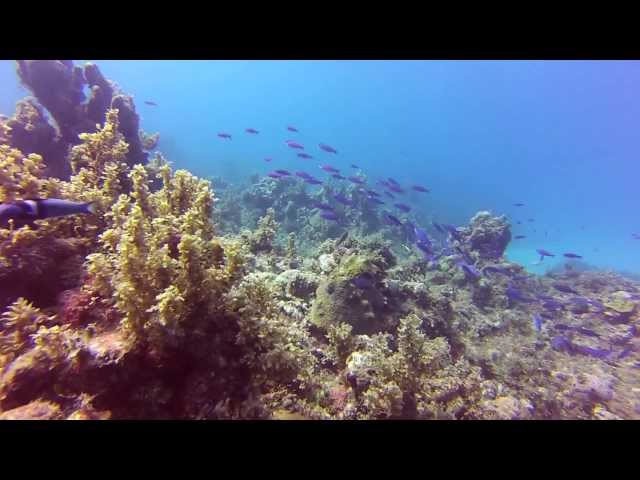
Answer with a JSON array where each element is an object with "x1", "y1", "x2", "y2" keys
[{"x1": 0, "y1": 198, "x2": 96, "y2": 228}]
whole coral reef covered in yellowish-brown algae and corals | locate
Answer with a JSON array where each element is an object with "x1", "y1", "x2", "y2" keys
[{"x1": 0, "y1": 61, "x2": 640, "y2": 419}]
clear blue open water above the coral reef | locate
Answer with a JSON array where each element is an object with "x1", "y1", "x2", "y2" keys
[{"x1": 0, "y1": 60, "x2": 640, "y2": 273}]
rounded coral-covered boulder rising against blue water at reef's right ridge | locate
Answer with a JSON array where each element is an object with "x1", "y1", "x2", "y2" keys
[{"x1": 463, "y1": 212, "x2": 511, "y2": 260}]
